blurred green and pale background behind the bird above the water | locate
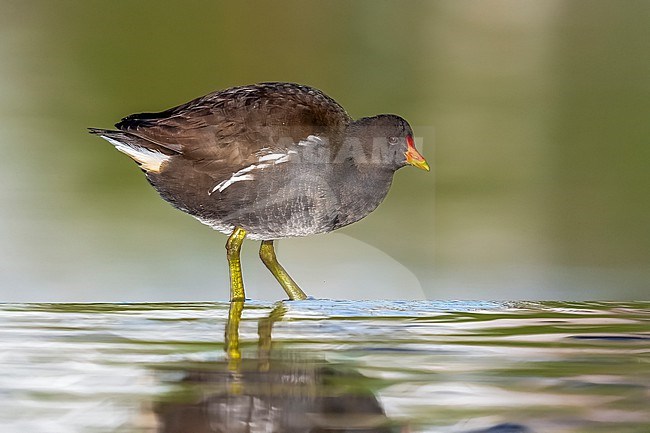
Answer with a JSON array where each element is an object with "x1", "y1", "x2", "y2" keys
[{"x1": 0, "y1": 0, "x2": 650, "y2": 301}]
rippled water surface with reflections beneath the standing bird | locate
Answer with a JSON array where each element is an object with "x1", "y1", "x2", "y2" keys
[{"x1": 0, "y1": 300, "x2": 650, "y2": 433}]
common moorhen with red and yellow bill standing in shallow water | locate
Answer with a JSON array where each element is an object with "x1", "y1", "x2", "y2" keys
[{"x1": 90, "y1": 83, "x2": 429, "y2": 301}]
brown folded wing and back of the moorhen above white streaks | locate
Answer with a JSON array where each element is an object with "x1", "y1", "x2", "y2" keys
[{"x1": 115, "y1": 83, "x2": 351, "y2": 171}]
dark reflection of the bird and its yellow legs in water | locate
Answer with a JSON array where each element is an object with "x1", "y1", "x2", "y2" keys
[{"x1": 155, "y1": 302, "x2": 408, "y2": 433}]
